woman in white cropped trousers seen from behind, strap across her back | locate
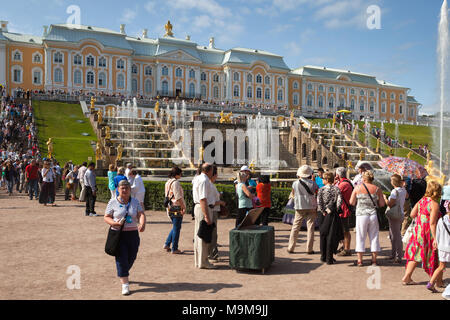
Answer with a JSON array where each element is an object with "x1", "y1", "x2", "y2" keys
[{"x1": 350, "y1": 170, "x2": 385, "y2": 267}]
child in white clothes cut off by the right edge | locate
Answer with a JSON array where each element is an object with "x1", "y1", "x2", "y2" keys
[{"x1": 427, "y1": 202, "x2": 450, "y2": 292}]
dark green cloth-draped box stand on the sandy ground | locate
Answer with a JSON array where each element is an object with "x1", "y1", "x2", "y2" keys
[{"x1": 230, "y1": 226, "x2": 275, "y2": 273}]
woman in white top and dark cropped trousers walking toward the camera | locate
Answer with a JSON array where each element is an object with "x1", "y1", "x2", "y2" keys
[{"x1": 104, "y1": 180, "x2": 146, "y2": 295}]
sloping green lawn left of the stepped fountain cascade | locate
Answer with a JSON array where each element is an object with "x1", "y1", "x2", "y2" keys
[{"x1": 33, "y1": 101, "x2": 97, "y2": 164}]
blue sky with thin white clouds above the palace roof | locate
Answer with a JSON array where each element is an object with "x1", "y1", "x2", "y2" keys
[{"x1": 0, "y1": 0, "x2": 448, "y2": 113}]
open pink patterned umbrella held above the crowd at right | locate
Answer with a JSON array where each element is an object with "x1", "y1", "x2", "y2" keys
[{"x1": 378, "y1": 157, "x2": 428, "y2": 179}]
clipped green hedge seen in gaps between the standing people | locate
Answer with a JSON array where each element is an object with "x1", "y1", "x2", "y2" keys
[{"x1": 92, "y1": 177, "x2": 389, "y2": 230}]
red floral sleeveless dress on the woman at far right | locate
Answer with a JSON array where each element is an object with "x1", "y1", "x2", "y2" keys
[{"x1": 405, "y1": 197, "x2": 438, "y2": 277}]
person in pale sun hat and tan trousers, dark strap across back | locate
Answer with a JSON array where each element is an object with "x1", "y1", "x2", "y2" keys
[{"x1": 287, "y1": 165, "x2": 319, "y2": 254}]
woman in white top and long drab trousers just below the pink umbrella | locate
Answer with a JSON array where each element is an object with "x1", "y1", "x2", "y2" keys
[{"x1": 384, "y1": 174, "x2": 406, "y2": 264}]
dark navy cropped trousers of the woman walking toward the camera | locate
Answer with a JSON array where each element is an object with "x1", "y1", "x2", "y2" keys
[{"x1": 116, "y1": 230, "x2": 141, "y2": 278}]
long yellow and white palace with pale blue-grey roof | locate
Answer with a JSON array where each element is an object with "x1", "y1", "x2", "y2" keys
[{"x1": 0, "y1": 21, "x2": 420, "y2": 121}]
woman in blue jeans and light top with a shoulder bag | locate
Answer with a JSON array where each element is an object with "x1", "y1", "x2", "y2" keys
[{"x1": 164, "y1": 167, "x2": 186, "y2": 254}]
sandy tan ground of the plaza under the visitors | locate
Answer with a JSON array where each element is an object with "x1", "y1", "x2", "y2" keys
[{"x1": 0, "y1": 190, "x2": 446, "y2": 300}]
